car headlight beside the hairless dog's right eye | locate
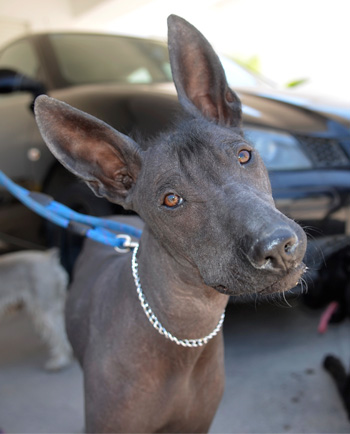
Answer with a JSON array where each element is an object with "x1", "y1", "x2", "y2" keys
[{"x1": 245, "y1": 128, "x2": 312, "y2": 170}]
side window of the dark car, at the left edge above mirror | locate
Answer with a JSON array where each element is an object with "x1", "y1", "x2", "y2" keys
[{"x1": 0, "y1": 40, "x2": 39, "y2": 79}]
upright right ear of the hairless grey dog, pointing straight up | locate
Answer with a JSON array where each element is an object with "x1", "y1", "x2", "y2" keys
[{"x1": 168, "y1": 15, "x2": 242, "y2": 127}]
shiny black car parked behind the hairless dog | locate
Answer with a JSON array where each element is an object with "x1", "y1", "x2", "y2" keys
[{"x1": 0, "y1": 33, "x2": 350, "y2": 256}]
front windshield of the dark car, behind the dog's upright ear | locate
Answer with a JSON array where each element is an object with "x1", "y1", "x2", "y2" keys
[{"x1": 49, "y1": 34, "x2": 261, "y2": 87}]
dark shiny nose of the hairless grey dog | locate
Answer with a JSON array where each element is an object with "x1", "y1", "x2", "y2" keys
[{"x1": 249, "y1": 228, "x2": 304, "y2": 272}]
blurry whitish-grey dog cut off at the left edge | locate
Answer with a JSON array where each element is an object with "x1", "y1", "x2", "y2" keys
[{"x1": 0, "y1": 249, "x2": 72, "y2": 370}]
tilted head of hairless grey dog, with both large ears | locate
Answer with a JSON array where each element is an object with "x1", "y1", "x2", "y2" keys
[{"x1": 35, "y1": 16, "x2": 306, "y2": 295}]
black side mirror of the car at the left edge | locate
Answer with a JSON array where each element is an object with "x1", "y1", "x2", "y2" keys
[{"x1": 0, "y1": 69, "x2": 46, "y2": 99}]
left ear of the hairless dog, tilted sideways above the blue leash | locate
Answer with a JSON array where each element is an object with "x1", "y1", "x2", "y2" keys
[{"x1": 35, "y1": 95, "x2": 142, "y2": 208}]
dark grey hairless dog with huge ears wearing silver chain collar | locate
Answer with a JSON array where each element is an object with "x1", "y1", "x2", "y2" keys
[{"x1": 35, "y1": 15, "x2": 306, "y2": 433}]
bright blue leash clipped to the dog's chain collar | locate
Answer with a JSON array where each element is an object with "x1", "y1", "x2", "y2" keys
[{"x1": 0, "y1": 170, "x2": 142, "y2": 251}]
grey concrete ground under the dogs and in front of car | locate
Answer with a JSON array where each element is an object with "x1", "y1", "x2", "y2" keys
[{"x1": 0, "y1": 302, "x2": 350, "y2": 433}]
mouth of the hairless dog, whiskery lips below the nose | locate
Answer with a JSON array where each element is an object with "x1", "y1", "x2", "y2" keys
[{"x1": 213, "y1": 263, "x2": 306, "y2": 296}]
